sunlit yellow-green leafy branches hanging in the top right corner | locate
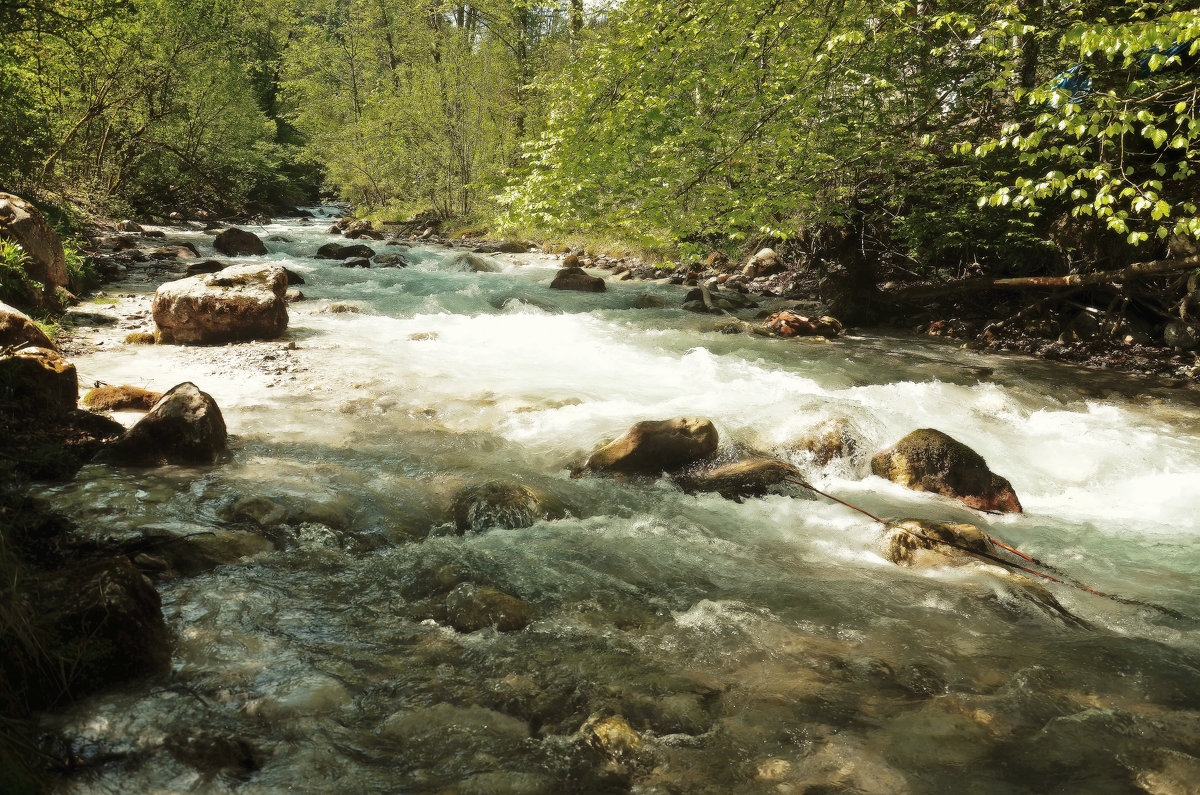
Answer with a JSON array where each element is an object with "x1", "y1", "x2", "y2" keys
[{"x1": 959, "y1": 1, "x2": 1200, "y2": 245}]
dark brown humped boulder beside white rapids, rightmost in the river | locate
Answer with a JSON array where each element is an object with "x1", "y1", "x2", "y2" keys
[{"x1": 871, "y1": 428, "x2": 1021, "y2": 513}]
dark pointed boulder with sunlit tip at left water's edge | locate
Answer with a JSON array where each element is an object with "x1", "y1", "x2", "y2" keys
[{"x1": 98, "y1": 382, "x2": 227, "y2": 466}]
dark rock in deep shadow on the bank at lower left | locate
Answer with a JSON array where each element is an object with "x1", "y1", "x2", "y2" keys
[{"x1": 31, "y1": 558, "x2": 170, "y2": 703}]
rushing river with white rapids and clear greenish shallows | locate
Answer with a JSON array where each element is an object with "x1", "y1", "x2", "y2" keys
[{"x1": 32, "y1": 213, "x2": 1200, "y2": 793}]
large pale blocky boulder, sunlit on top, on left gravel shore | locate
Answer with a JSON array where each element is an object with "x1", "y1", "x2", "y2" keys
[{"x1": 154, "y1": 265, "x2": 288, "y2": 343}]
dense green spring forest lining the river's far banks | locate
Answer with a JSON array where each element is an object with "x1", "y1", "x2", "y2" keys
[{"x1": 7, "y1": 0, "x2": 1200, "y2": 299}]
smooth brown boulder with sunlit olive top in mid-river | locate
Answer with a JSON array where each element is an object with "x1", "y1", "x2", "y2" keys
[{"x1": 586, "y1": 417, "x2": 718, "y2": 474}]
